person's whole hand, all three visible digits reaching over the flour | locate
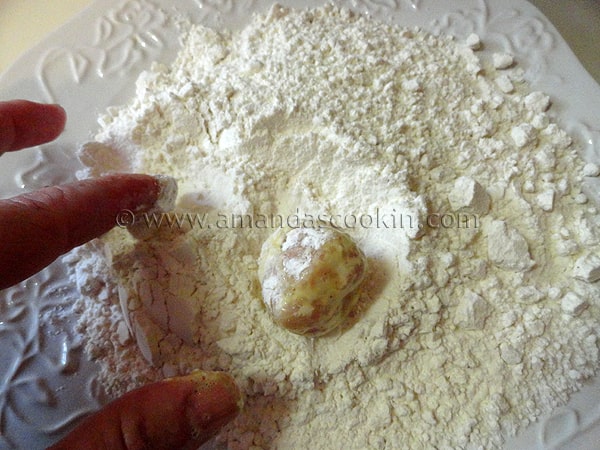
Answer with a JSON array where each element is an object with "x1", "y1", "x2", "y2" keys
[{"x1": 0, "y1": 100, "x2": 240, "y2": 450}]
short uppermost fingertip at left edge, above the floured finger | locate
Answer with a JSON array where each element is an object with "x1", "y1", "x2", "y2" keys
[{"x1": 0, "y1": 100, "x2": 66, "y2": 153}]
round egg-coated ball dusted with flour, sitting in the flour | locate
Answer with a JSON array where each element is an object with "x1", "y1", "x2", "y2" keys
[{"x1": 258, "y1": 227, "x2": 366, "y2": 337}]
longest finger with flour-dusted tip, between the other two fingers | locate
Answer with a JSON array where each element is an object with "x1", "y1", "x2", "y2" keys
[{"x1": 0, "y1": 174, "x2": 161, "y2": 289}]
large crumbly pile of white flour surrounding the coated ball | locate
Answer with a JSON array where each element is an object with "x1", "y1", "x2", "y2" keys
[{"x1": 68, "y1": 6, "x2": 600, "y2": 449}]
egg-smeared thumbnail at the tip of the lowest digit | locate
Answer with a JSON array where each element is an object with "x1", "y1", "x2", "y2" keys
[{"x1": 186, "y1": 371, "x2": 243, "y2": 442}]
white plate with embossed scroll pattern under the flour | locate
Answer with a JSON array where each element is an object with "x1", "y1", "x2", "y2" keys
[{"x1": 0, "y1": 0, "x2": 600, "y2": 449}]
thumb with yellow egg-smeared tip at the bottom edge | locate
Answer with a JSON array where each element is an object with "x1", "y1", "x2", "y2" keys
[{"x1": 49, "y1": 371, "x2": 241, "y2": 450}]
